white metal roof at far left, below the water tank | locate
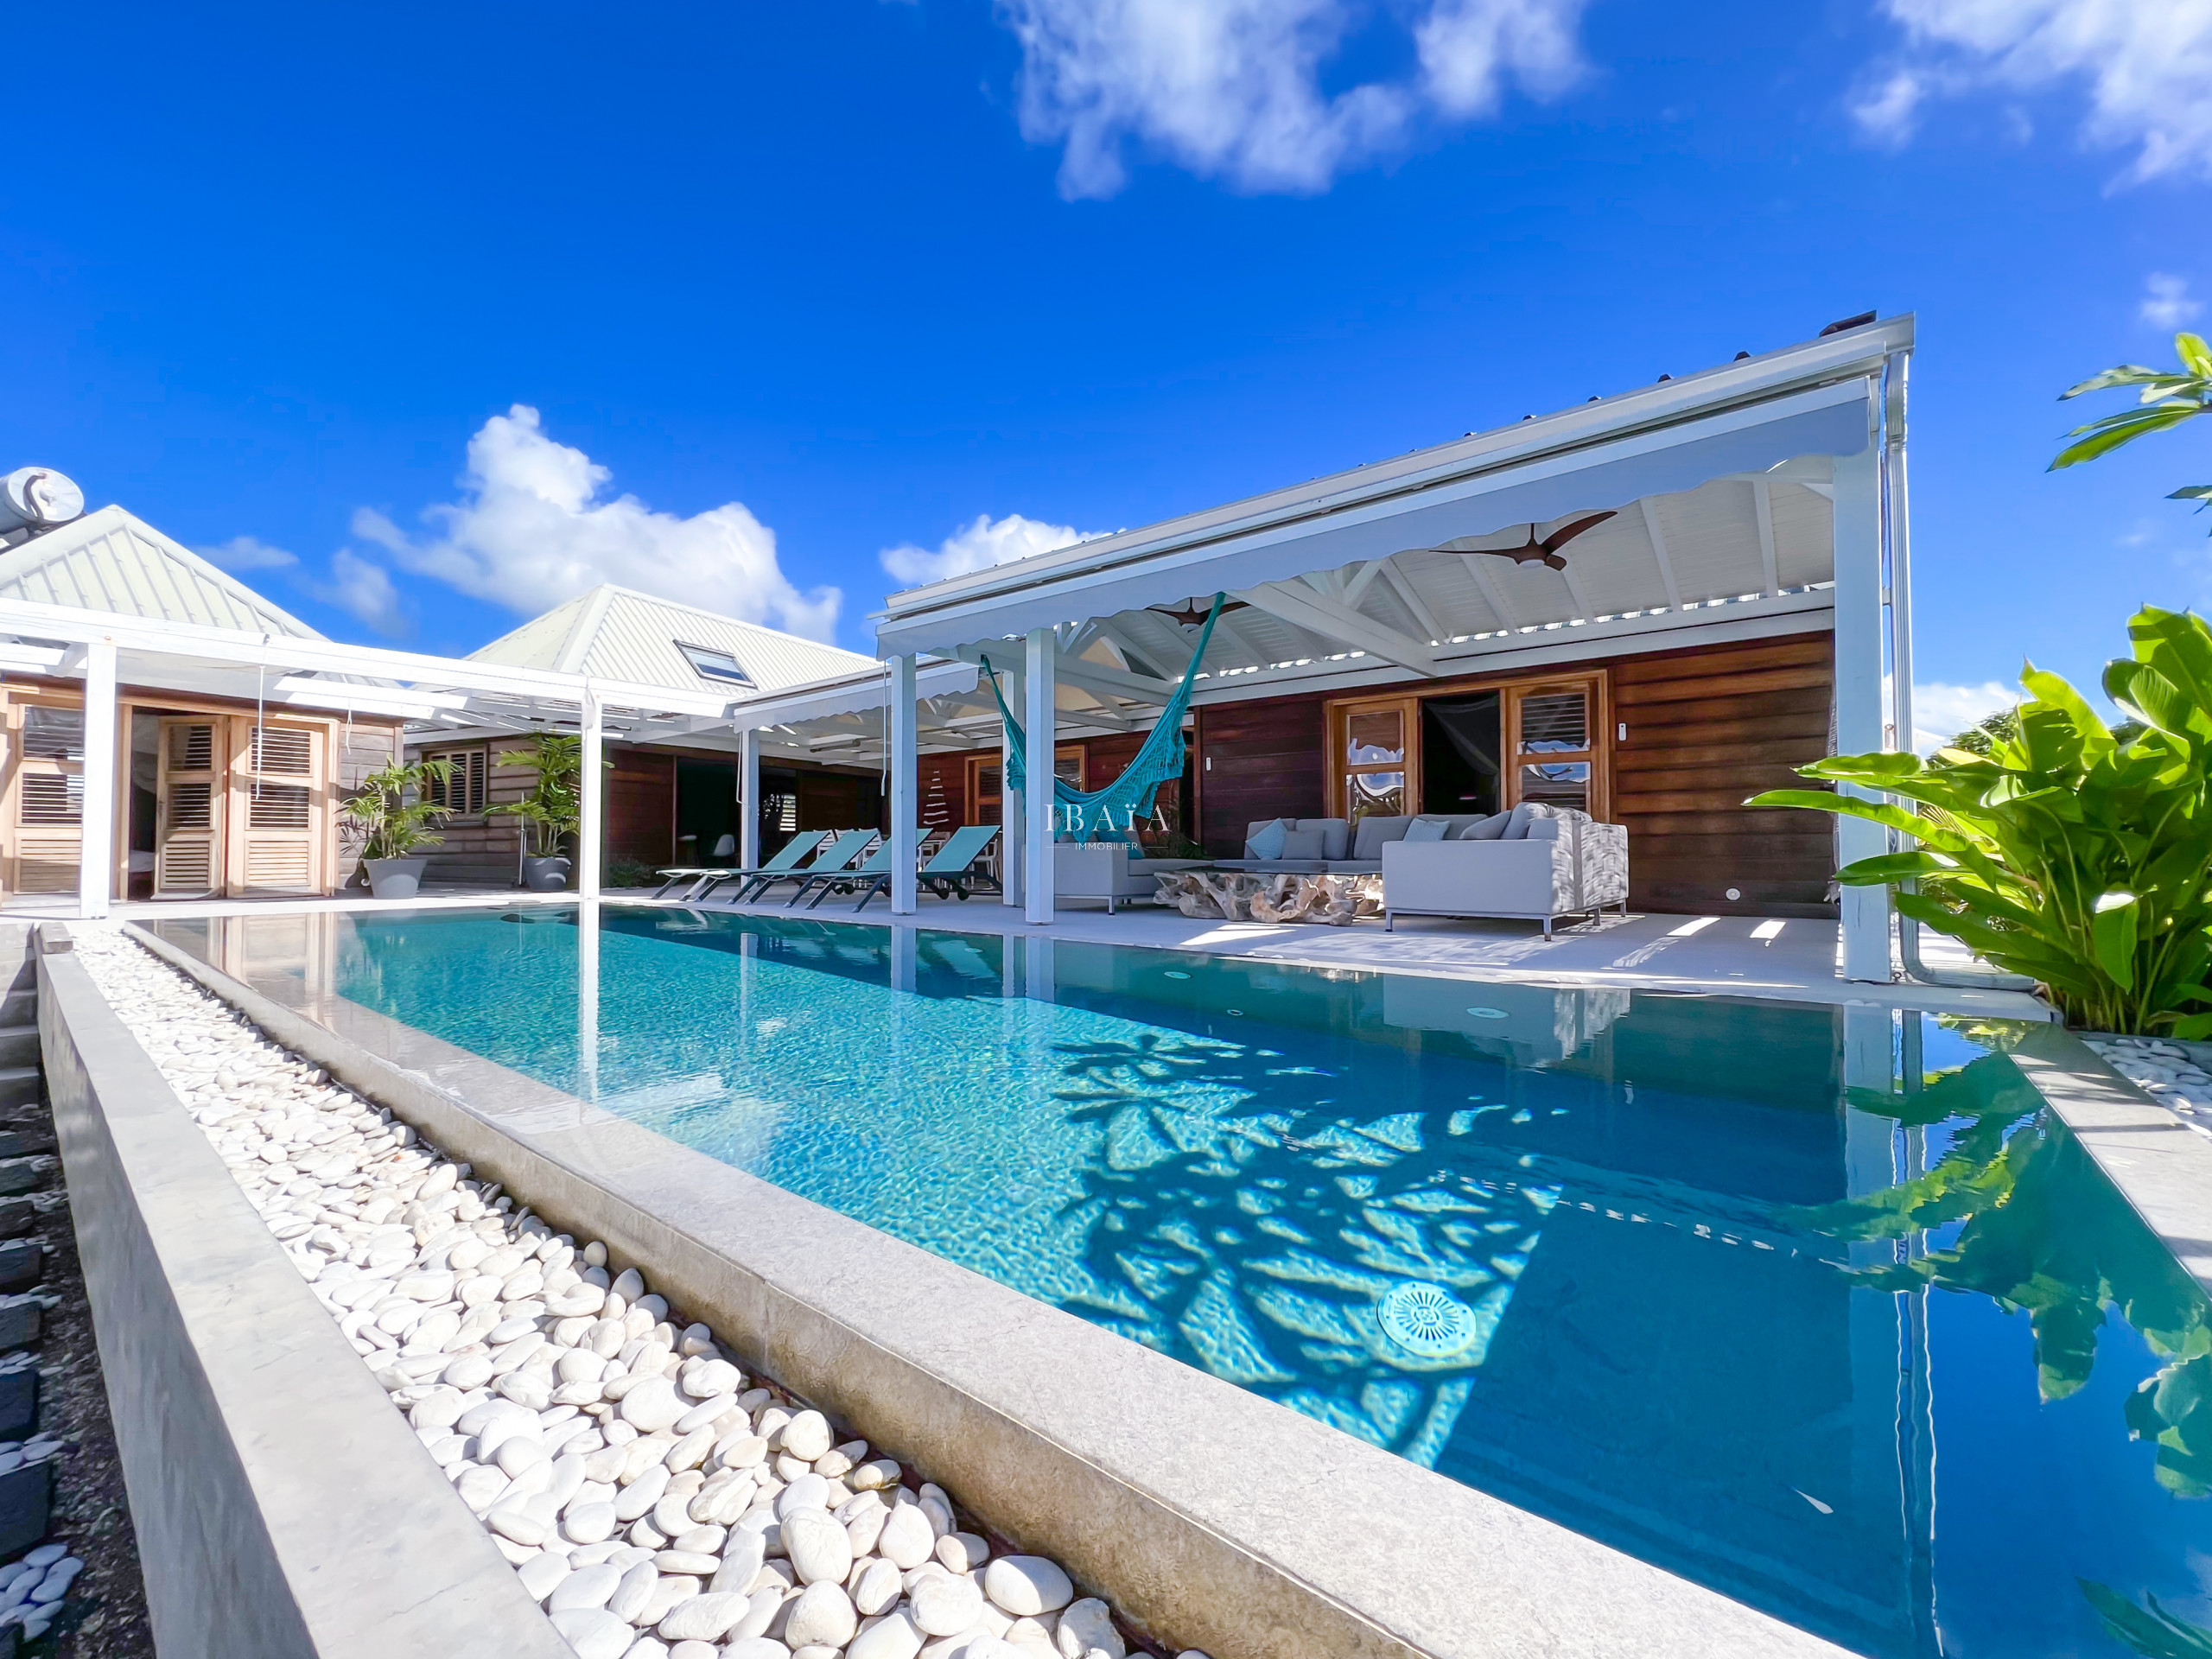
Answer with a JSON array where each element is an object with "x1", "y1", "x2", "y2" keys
[{"x1": 0, "y1": 506, "x2": 323, "y2": 639}]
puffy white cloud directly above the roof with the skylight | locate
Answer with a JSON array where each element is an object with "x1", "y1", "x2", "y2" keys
[{"x1": 354, "y1": 403, "x2": 842, "y2": 639}]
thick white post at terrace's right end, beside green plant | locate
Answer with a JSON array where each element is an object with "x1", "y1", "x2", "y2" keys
[{"x1": 1836, "y1": 438, "x2": 1889, "y2": 984}]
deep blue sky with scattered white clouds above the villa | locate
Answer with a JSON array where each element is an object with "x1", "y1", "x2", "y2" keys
[{"x1": 0, "y1": 0, "x2": 2212, "y2": 739}]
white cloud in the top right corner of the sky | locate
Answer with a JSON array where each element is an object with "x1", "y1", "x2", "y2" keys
[{"x1": 1852, "y1": 0, "x2": 2212, "y2": 179}]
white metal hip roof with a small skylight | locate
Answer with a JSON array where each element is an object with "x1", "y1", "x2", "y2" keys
[{"x1": 469, "y1": 582, "x2": 882, "y2": 699}]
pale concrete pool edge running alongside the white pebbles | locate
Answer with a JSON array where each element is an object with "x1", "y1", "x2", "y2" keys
[{"x1": 126, "y1": 927, "x2": 1842, "y2": 1659}]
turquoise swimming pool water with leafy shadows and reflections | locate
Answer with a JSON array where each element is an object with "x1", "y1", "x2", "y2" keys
[{"x1": 163, "y1": 905, "x2": 2212, "y2": 1659}]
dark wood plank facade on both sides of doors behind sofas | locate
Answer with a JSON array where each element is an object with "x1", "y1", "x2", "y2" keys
[{"x1": 1197, "y1": 632, "x2": 1836, "y2": 916}]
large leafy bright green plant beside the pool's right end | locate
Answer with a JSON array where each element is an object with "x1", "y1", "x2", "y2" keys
[{"x1": 1745, "y1": 606, "x2": 2212, "y2": 1038}]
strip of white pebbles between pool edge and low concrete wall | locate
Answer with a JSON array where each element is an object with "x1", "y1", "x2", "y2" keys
[{"x1": 78, "y1": 925, "x2": 1205, "y2": 1659}]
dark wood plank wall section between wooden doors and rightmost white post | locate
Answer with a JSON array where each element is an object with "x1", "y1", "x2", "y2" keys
[{"x1": 1612, "y1": 632, "x2": 1836, "y2": 916}]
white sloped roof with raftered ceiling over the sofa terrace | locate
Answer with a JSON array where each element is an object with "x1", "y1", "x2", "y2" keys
[{"x1": 876, "y1": 316, "x2": 1913, "y2": 675}]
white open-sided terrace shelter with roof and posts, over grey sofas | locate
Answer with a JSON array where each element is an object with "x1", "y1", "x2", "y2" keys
[{"x1": 854, "y1": 316, "x2": 1913, "y2": 980}]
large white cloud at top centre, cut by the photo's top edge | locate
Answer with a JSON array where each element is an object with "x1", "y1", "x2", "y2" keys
[{"x1": 998, "y1": 0, "x2": 1584, "y2": 197}]
